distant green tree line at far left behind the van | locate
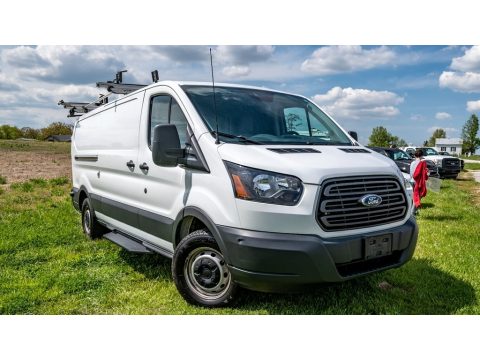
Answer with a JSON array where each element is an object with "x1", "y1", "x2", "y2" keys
[{"x1": 0, "y1": 122, "x2": 73, "y2": 140}]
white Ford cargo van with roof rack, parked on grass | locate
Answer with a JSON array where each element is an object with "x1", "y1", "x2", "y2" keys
[{"x1": 61, "y1": 74, "x2": 418, "y2": 306}]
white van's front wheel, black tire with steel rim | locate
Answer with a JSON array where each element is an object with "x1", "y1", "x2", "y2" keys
[{"x1": 172, "y1": 230, "x2": 238, "y2": 307}]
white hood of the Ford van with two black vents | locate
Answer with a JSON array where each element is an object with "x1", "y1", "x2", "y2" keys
[{"x1": 218, "y1": 143, "x2": 403, "y2": 184}]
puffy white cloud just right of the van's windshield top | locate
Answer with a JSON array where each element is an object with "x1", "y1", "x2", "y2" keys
[{"x1": 313, "y1": 86, "x2": 403, "y2": 119}]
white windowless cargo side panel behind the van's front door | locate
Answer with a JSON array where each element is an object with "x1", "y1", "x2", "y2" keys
[{"x1": 72, "y1": 92, "x2": 144, "y2": 203}]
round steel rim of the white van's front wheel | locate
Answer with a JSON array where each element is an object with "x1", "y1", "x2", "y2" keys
[{"x1": 183, "y1": 247, "x2": 232, "y2": 300}]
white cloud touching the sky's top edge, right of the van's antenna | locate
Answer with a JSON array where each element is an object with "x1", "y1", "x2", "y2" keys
[{"x1": 301, "y1": 45, "x2": 395, "y2": 75}]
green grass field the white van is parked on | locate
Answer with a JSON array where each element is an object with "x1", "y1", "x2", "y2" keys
[{"x1": 0, "y1": 179, "x2": 480, "y2": 314}]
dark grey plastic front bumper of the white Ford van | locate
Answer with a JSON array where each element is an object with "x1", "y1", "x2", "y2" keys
[{"x1": 218, "y1": 217, "x2": 418, "y2": 291}]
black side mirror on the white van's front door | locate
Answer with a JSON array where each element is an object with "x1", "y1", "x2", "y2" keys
[{"x1": 152, "y1": 124, "x2": 185, "y2": 167}]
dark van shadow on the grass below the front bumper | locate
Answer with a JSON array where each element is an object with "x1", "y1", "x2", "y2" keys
[{"x1": 237, "y1": 259, "x2": 476, "y2": 315}]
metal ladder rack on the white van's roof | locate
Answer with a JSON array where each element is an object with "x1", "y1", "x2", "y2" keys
[{"x1": 58, "y1": 70, "x2": 158, "y2": 117}]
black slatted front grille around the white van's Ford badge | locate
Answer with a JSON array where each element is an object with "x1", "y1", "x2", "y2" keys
[{"x1": 317, "y1": 176, "x2": 408, "y2": 231}]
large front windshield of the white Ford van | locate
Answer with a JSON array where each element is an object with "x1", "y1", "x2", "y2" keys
[{"x1": 182, "y1": 85, "x2": 352, "y2": 145}]
